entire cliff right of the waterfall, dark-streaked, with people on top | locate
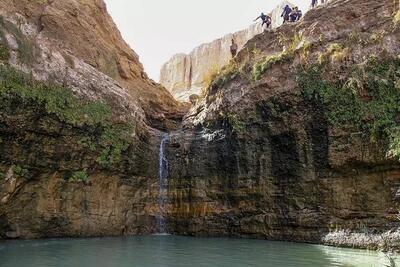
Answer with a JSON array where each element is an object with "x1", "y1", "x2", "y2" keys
[{"x1": 162, "y1": 0, "x2": 400, "y2": 248}]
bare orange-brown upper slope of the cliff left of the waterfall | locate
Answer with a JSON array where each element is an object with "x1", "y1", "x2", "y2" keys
[{"x1": 0, "y1": 0, "x2": 186, "y2": 128}]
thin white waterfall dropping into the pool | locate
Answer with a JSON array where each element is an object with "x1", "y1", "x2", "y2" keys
[{"x1": 157, "y1": 133, "x2": 169, "y2": 234}]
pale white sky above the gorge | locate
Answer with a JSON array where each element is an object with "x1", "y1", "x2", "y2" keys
[{"x1": 105, "y1": 0, "x2": 311, "y2": 81}]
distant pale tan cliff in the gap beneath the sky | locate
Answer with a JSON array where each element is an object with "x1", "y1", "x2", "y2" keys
[{"x1": 160, "y1": 1, "x2": 292, "y2": 101}]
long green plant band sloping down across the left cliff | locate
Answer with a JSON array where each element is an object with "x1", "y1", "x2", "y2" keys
[{"x1": 0, "y1": 66, "x2": 134, "y2": 167}]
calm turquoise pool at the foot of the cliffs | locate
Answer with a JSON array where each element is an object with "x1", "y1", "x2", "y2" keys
[{"x1": 0, "y1": 236, "x2": 400, "y2": 267}]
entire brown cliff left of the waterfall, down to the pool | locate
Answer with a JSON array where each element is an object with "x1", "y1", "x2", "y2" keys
[{"x1": 0, "y1": 0, "x2": 180, "y2": 238}]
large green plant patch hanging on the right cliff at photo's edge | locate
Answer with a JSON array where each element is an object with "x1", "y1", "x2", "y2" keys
[{"x1": 297, "y1": 57, "x2": 400, "y2": 159}]
